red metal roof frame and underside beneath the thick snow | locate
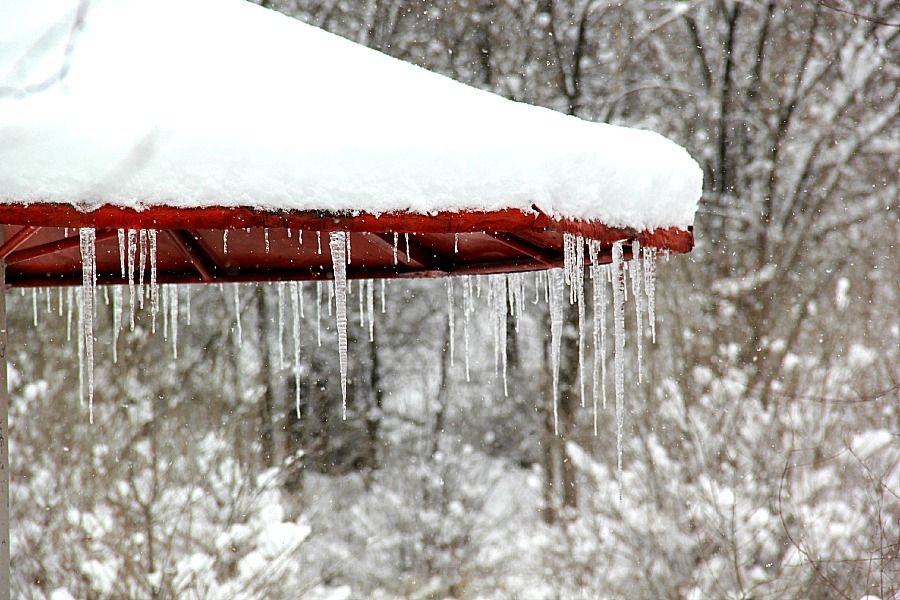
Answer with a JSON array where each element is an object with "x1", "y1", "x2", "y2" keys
[{"x1": 0, "y1": 204, "x2": 694, "y2": 287}]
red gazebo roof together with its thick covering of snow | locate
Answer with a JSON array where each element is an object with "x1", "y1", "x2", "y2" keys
[{"x1": 0, "y1": 0, "x2": 702, "y2": 285}]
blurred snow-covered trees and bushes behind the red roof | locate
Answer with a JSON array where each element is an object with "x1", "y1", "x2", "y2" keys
[{"x1": 9, "y1": 0, "x2": 900, "y2": 600}]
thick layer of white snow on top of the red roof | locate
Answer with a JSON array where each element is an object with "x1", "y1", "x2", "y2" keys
[{"x1": 0, "y1": 0, "x2": 702, "y2": 229}]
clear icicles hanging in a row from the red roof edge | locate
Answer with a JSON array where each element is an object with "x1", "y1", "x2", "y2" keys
[{"x1": 67, "y1": 228, "x2": 657, "y2": 490}]
